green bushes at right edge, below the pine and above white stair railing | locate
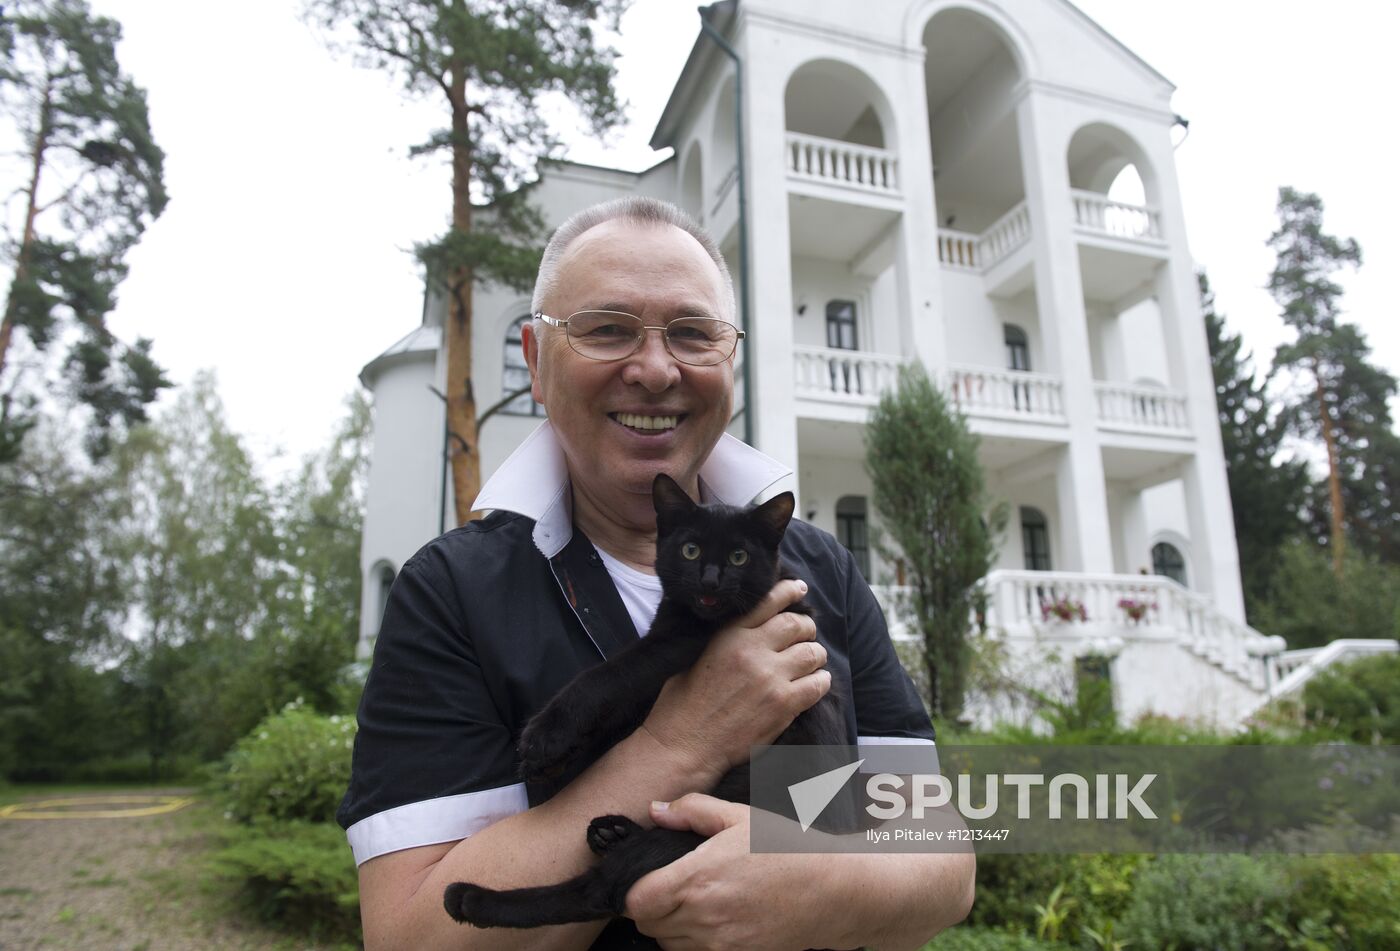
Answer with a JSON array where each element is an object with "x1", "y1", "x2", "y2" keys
[{"x1": 1259, "y1": 539, "x2": 1400, "y2": 648}]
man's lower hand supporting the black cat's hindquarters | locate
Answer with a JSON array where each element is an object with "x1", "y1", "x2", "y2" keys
[{"x1": 627, "y1": 793, "x2": 820, "y2": 951}]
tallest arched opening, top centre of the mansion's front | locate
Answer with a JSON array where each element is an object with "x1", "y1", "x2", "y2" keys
[{"x1": 924, "y1": 8, "x2": 1026, "y2": 238}]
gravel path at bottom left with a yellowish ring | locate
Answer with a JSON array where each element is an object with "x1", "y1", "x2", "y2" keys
[{"x1": 0, "y1": 789, "x2": 348, "y2": 951}]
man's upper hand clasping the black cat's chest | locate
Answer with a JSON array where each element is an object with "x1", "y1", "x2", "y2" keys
[{"x1": 643, "y1": 581, "x2": 832, "y2": 780}]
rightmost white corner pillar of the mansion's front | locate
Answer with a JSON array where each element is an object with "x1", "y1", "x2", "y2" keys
[{"x1": 1148, "y1": 132, "x2": 1245, "y2": 620}]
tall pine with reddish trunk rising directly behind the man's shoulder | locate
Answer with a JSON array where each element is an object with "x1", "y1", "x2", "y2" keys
[{"x1": 307, "y1": 0, "x2": 626, "y2": 522}]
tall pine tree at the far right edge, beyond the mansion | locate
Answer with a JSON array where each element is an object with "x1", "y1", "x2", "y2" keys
[{"x1": 1268, "y1": 188, "x2": 1400, "y2": 576}]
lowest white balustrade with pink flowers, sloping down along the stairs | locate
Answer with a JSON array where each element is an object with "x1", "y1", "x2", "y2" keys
[{"x1": 983, "y1": 570, "x2": 1268, "y2": 689}]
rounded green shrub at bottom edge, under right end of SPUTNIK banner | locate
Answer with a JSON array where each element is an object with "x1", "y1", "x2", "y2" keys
[{"x1": 1117, "y1": 854, "x2": 1289, "y2": 951}]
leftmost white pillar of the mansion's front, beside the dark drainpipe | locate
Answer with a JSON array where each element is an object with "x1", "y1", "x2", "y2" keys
[{"x1": 741, "y1": 34, "x2": 801, "y2": 498}]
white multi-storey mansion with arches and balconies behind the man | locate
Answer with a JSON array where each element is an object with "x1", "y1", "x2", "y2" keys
[{"x1": 352, "y1": 0, "x2": 1393, "y2": 724}]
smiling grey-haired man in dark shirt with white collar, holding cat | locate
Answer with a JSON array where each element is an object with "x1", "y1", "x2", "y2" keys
[{"x1": 340, "y1": 199, "x2": 973, "y2": 948}]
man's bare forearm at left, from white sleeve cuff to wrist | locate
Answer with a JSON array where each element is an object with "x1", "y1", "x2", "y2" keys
[{"x1": 361, "y1": 731, "x2": 715, "y2": 951}]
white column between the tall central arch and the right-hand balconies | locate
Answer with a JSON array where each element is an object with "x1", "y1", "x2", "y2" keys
[{"x1": 1016, "y1": 91, "x2": 1113, "y2": 573}]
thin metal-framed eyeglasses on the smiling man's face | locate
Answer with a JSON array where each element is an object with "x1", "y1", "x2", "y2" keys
[{"x1": 535, "y1": 311, "x2": 743, "y2": 367}]
